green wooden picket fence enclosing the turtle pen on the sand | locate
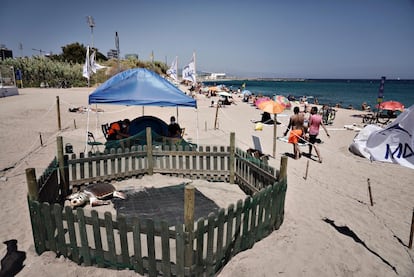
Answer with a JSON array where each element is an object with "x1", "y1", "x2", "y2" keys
[{"x1": 26, "y1": 130, "x2": 287, "y2": 276}]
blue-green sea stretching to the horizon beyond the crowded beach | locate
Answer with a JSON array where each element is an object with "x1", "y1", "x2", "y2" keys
[{"x1": 203, "y1": 79, "x2": 414, "y2": 110}]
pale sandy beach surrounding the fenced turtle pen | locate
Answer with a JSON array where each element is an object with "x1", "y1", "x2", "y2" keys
[{"x1": 0, "y1": 88, "x2": 414, "y2": 277}]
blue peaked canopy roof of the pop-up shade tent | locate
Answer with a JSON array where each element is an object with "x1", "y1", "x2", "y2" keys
[{"x1": 89, "y1": 68, "x2": 197, "y2": 108}]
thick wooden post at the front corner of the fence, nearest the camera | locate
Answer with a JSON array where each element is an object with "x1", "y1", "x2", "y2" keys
[{"x1": 184, "y1": 185, "x2": 195, "y2": 268}]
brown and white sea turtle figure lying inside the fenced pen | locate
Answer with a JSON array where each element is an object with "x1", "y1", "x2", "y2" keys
[{"x1": 67, "y1": 183, "x2": 126, "y2": 207}]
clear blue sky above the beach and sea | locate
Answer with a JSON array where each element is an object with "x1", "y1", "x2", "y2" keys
[{"x1": 0, "y1": 0, "x2": 414, "y2": 79}]
